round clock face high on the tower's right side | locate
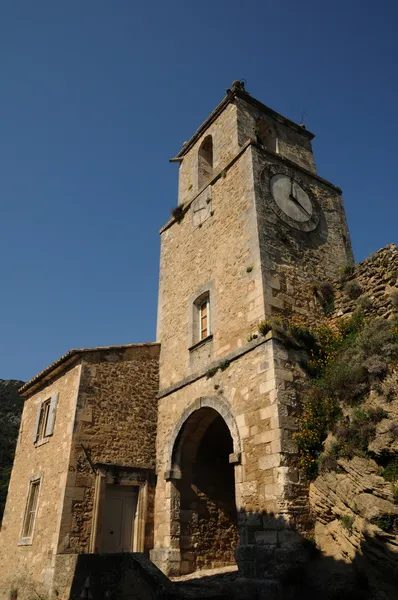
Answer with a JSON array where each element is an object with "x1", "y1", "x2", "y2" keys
[{"x1": 261, "y1": 165, "x2": 319, "y2": 231}]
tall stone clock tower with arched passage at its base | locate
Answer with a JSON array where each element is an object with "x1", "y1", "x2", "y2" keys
[{"x1": 152, "y1": 81, "x2": 353, "y2": 575}]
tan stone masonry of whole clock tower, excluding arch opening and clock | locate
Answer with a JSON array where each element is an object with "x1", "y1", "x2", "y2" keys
[{"x1": 153, "y1": 92, "x2": 352, "y2": 571}]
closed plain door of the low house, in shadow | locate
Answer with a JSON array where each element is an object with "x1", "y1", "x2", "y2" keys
[{"x1": 101, "y1": 485, "x2": 137, "y2": 553}]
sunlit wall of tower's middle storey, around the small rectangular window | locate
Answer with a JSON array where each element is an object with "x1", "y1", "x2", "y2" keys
[{"x1": 158, "y1": 151, "x2": 264, "y2": 389}]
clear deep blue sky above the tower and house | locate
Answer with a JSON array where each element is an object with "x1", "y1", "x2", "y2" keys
[{"x1": 0, "y1": 0, "x2": 398, "y2": 380}]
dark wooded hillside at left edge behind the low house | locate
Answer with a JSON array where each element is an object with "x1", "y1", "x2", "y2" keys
[{"x1": 0, "y1": 379, "x2": 24, "y2": 523}]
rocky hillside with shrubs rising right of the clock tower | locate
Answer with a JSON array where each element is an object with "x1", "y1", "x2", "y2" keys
[{"x1": 304, "y1": 245, "x2": 398, "y2": 599}]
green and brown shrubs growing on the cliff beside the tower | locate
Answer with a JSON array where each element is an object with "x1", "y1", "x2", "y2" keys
[{"x1": 282, "y1": 310, "x2": 398, "y2": 479}]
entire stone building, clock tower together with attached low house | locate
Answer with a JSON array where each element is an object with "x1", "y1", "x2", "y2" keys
[{"x1": 0, "y1": 81, "x2": 353, "y2": 593}]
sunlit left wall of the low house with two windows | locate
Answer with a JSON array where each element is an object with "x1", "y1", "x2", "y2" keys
[{"x1": 0, "y1": 364, "x2": 81, "y2": 598}]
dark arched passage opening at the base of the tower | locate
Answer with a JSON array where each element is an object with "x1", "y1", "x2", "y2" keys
[{"x1": 170, "y1": 401, "x2": 239, "y2": 574}]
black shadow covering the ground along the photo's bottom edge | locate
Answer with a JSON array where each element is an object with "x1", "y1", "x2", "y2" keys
[{"x1": 63, "y1": 512, "x2": 398, "y2": 600}]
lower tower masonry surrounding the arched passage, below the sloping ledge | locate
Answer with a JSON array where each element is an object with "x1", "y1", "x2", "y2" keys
[{"x1": 151, "y1": 334, "x2": 306, "y2": 574}]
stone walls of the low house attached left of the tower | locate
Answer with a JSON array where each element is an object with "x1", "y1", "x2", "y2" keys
[{"x1": 0, "y1": 344, "x2": 159, "y2": 598}]
